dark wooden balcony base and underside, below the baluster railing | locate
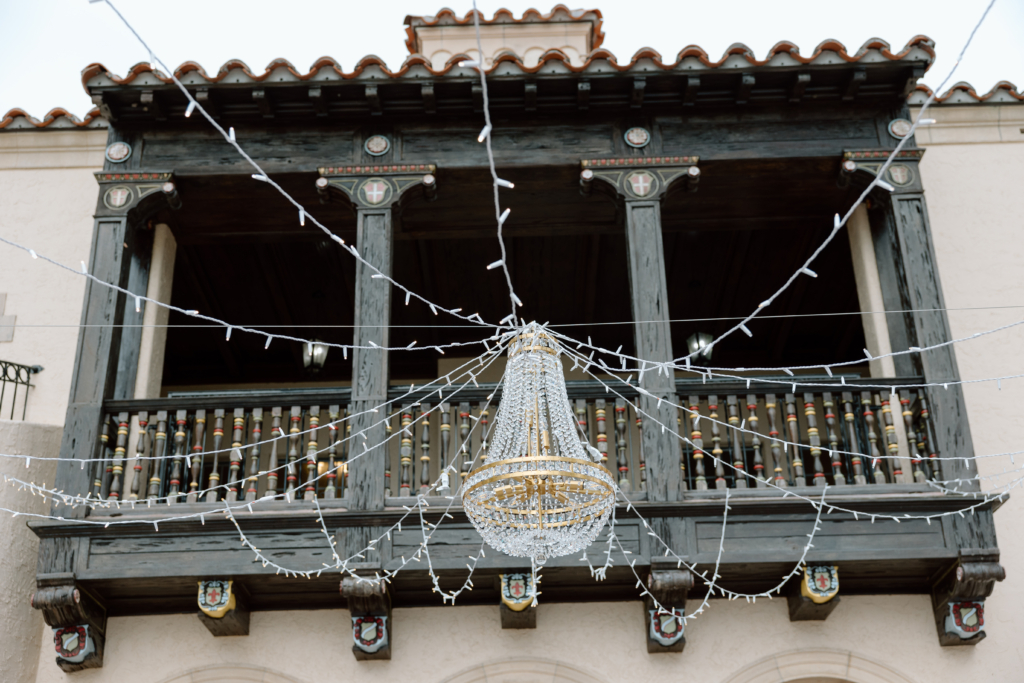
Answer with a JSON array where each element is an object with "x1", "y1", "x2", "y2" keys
[{"x1": 31, "y1": 485, "x2": 992, "y2": 615}]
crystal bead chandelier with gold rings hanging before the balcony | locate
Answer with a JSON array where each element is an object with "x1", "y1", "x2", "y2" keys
[{"x1": 463, "y1": 323, "x2": 615, "y2": 564}]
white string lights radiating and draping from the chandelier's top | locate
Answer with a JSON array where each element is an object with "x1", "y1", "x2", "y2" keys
[{"x1": 0, "y1": 0, "x2": 1011, "y2": 621}]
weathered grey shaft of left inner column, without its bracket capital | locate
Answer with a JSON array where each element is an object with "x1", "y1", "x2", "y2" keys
[{"x1": 346, "y1": 208, "x2": 393, "y2": 510}]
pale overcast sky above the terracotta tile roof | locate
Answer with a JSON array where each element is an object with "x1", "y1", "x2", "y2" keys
[{"x1": 0, "y1": 0, "x2": 1024, "y2": 118}]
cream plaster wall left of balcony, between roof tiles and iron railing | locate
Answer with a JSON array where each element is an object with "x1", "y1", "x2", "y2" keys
[{"x1": 0, "y1": 130, "x2": 106, "y2": 425}]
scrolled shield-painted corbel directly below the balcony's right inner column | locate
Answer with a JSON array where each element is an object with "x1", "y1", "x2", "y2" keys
[{"x1": 644, "y1": 560, "x2": 693, "y2": 652}]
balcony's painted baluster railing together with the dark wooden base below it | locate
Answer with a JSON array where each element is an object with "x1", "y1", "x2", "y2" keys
[{"x1": 31, "y1": 378, "x2": 995, "y2": 615}]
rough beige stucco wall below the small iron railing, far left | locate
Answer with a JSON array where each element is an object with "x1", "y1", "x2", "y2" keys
[{"x1": 0, "y1": 420, "x2": 61, "y2": 683}]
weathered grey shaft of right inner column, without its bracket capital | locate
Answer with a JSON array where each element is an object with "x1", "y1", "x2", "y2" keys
[{"x1": 626, "y1": 201, "x2": 681, "y2": 501}]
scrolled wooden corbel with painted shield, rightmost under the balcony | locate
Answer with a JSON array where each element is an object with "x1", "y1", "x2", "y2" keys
[{"x1": 932, "y1": 548, "x2": 1007, "y2": 647}]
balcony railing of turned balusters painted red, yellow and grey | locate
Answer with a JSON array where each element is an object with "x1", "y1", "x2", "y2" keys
[{"x1": 92, "y1": 378, "x2": 940, "y2": 504}]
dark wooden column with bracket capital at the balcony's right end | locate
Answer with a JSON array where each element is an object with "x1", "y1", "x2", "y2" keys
[{"x1": 846, "y1": 150, "x2": 979, "y2": 490}]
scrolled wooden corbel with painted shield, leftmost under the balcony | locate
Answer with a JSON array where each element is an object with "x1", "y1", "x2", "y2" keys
[{"x1": 32, "y1": 573, "x2": 106, "y2": 674}]
